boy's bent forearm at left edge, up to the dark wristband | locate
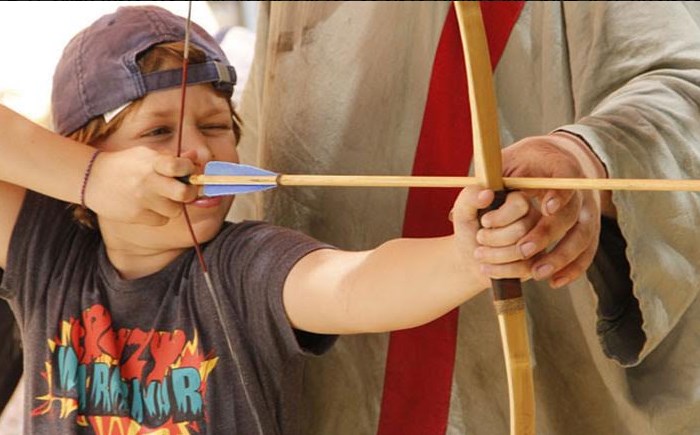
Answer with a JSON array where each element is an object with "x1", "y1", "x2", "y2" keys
[{"x1": 0, "y1": 105, "x2": 93, "y2": 203}]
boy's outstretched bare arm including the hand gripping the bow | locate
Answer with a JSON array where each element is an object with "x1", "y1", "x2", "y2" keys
[{"x1": 284, "y1": 188, "x2": 537, "y2": 334}]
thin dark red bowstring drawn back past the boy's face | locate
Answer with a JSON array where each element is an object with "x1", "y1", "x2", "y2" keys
[{"x1": 177, "y1": 0, "x2": 264, "y2": 435}]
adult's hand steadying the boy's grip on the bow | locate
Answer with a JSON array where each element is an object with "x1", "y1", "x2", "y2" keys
[{"x1": 503, "y1": 132, "x2": 614, "y2": 287}]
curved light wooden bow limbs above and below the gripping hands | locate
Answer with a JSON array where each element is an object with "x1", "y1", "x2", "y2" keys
[{"x1": 454, "y1": 1, "x2": 535, "y2": 435}]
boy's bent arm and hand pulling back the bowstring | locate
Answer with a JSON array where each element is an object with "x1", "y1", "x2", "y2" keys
[{"x1": 0, "y1": 105, "x2": 196, "y2": 268}]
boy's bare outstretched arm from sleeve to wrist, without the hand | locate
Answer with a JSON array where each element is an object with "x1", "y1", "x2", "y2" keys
[{"x1": 284, "y1": 236, "x2": 489, "y2": 334}]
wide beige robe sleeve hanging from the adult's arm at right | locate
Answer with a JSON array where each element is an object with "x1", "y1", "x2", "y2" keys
[{"x1": 561, "y1": 2, "x2": 700, "y2": 366}]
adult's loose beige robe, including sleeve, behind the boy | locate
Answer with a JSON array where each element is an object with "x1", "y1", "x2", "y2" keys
[{"x1": 232, "y1": 2, "x2": 700, "y2": 435}]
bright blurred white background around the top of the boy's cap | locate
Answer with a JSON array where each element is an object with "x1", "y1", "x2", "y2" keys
[{"x1": 0, "y1": 1, "x2": 258, "y2": 126}]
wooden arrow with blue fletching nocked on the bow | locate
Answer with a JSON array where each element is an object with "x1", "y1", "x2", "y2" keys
[{"x1": 183, "y1": 161, "x2": 700, "y2": 197}]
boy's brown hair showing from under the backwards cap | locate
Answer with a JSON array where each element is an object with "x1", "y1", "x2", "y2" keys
[{"x1": 68, "y1": 41, "x2": 242, "y2": 228}]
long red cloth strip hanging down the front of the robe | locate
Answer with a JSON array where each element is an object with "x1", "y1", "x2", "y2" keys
[{"x1": 378, "y1": 1, "x2": 524, "y2": 435}]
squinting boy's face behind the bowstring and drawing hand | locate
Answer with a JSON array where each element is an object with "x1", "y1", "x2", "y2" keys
[{"x1": 98, "y1": 84, "x2": 238, "y2": 248}]
